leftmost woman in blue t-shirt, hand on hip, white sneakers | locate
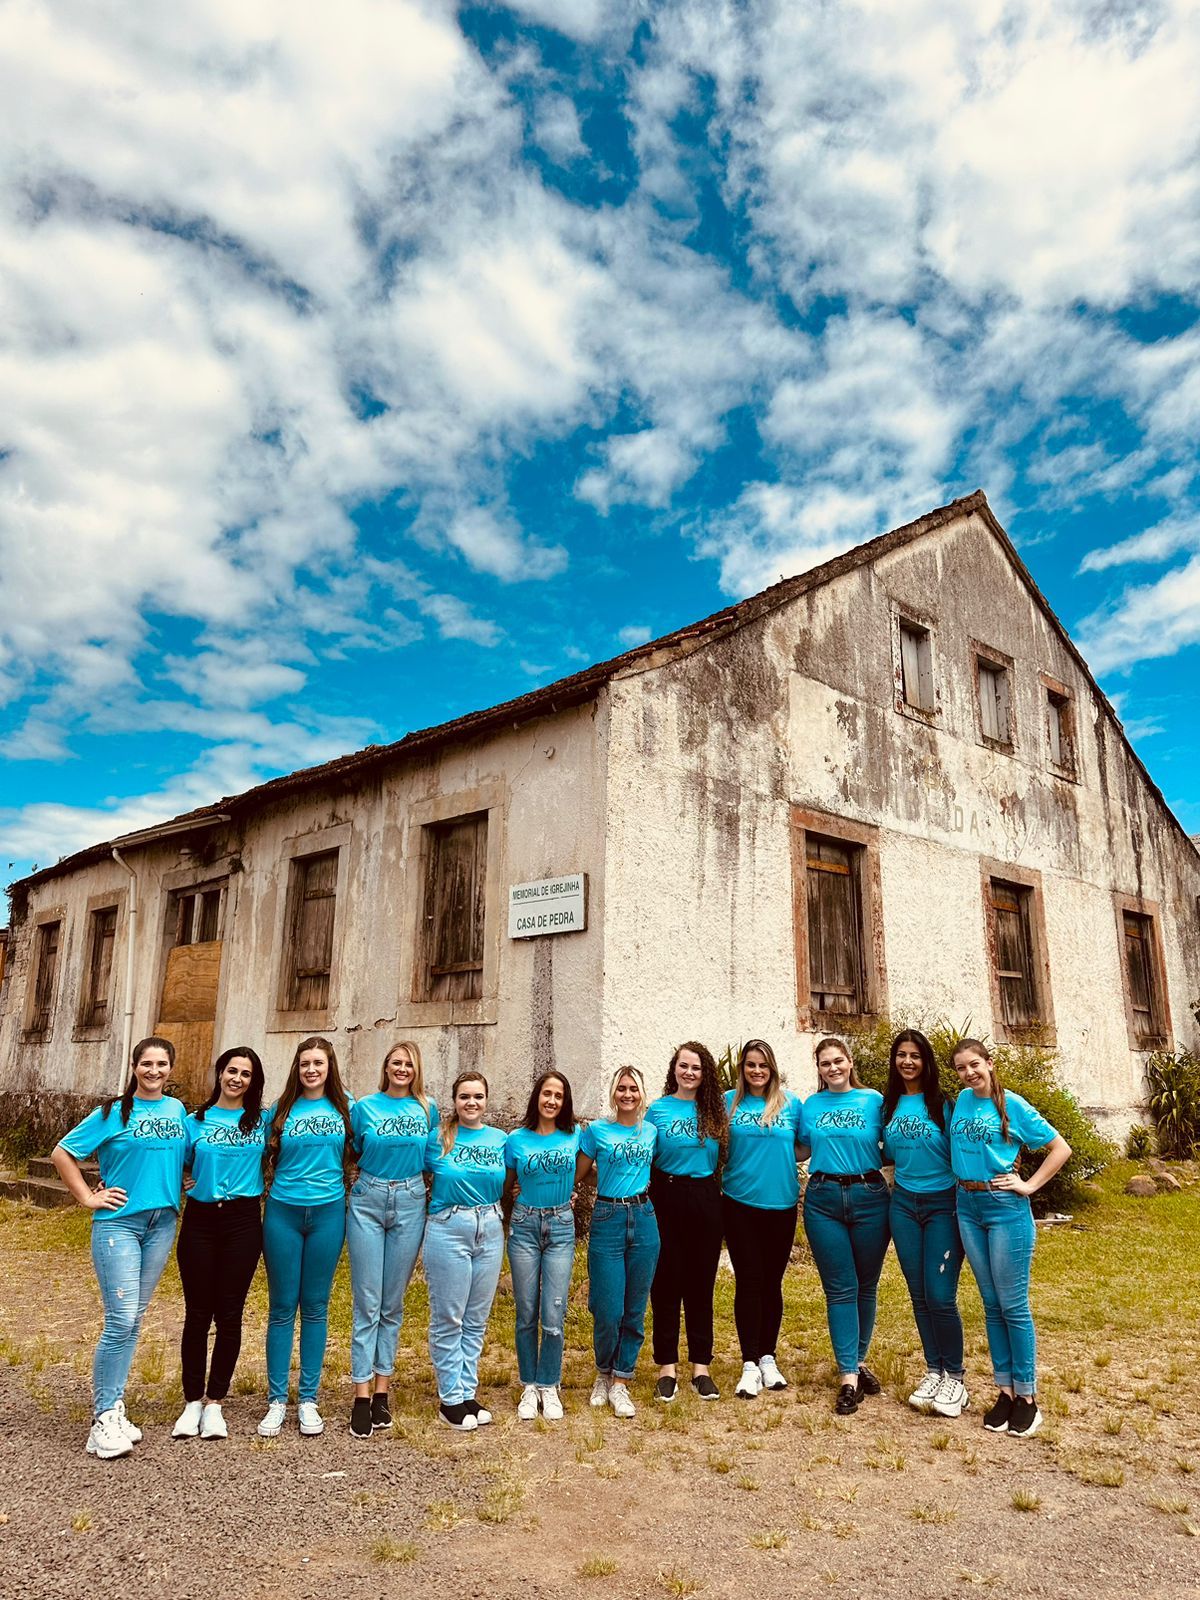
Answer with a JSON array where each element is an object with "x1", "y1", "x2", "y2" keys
[{"x1": 51, "y1": 1035, "x2": 187, "y2": 1461}]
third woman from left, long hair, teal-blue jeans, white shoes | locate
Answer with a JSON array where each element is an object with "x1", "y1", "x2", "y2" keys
[{"x1": 258, "y1": 1038, "x2": 354, "y2": 1438}]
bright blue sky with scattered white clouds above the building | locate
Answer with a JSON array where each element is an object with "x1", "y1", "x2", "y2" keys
[{"x1": 0, "y1": 0, "x2": 1200, "y2": 878}]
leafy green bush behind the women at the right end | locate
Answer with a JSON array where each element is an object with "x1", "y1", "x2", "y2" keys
[{"x1": 848, "y1": 1016, "x2": 1117, "y2": 1211}]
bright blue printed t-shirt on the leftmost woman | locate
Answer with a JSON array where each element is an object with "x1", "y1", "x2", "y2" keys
[{"x1": 59, "y1": 1094, "x2": 187, "y2": 1222}]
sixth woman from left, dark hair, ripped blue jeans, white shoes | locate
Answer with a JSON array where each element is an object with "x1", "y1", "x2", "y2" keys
[{"x1": 504, "y1": 1072, "x2": 579, "y2": 1422}]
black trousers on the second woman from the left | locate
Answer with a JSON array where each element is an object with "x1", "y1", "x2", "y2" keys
[{"x1": 174, "y1": 1197, "x2": 262, "y2": 1400}]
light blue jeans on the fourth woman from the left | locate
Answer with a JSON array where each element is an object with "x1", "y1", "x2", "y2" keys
[{"x1": 346, "y1": 1173, "x2": 426, "y2": 1384}]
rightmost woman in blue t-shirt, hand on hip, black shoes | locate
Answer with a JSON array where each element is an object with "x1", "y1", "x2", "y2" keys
[{"x1": 950, "y1": 1038, "x2": 1070, "y2": 1438}]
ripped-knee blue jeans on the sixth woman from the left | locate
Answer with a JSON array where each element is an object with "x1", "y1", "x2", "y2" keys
[{"x1": 509, "y1": 1202, "x2": 574, "y2": 1389}]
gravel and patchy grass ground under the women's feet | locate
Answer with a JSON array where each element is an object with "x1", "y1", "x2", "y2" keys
[{"x1": 0, "y1": 1202, "x2": 1200, "y2": 1600}]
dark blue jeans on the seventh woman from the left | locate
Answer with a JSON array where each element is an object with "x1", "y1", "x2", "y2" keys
[{"x1": 587, "y1": 1200, "x2": 659, "y2": 1378}]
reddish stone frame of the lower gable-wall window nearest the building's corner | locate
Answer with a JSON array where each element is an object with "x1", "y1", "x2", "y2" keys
[{"x1": 790, "y1": 805, "x2": 888, "y2": 1034}]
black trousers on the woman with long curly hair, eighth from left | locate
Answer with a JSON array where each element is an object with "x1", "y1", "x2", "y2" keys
[{"x1": 650, "y1": 1168, "x2": 722, "y2": 1366}]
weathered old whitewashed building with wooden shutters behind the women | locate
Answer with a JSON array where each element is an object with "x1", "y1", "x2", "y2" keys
[{"x1": 0, "y1": 494, "x2": 1200, "y2": 1125}]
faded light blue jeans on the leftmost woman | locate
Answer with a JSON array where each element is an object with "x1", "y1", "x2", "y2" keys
[{"x1": 91, "y1": 1206, "x2": 178, "y2": 1416}]
